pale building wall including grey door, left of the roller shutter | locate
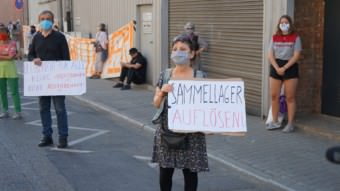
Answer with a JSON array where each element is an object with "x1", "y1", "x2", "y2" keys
[{"x1": 72, "y1": 0, "x2": 168, "y2": 85}]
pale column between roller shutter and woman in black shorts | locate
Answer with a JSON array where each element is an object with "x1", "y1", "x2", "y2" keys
[{"x1": 261, "y1": 0, "x2": 294, "y2": 116}]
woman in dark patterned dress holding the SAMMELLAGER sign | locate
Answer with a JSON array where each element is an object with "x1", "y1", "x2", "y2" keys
[{"x1": 152, "y1": 35, "x2": 209, "y2": 191}]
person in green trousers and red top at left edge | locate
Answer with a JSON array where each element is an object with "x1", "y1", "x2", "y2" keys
[{"x1": 0, "y1": 26, "x2": 21, "y2": 119}]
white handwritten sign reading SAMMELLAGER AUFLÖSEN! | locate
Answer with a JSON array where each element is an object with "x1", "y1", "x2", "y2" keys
[{"x1": 168, "y1": 80, "x2": 247, "y2": 133}]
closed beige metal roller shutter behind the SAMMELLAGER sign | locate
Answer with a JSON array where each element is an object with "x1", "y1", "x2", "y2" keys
[{"x1": 169, "y1": 0, "x2": 264, "y2": 115}]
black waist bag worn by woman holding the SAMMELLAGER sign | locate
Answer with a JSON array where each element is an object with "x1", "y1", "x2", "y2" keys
[{"x1": 160, "y1": 127, "x2": 189, "y2": 150}]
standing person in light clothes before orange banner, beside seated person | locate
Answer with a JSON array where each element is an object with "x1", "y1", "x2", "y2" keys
[{"x1": 90, "y1": 23, "x2": 109, "y2": 79}]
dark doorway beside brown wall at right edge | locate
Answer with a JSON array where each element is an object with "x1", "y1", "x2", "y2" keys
[{"x1": 321, "y1": 0, "x2": 340, "y2": 117}]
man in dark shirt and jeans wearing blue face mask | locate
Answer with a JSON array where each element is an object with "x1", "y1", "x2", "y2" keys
[{"x1": 28, "y1": 10, "x2": 70, "y2": 148}]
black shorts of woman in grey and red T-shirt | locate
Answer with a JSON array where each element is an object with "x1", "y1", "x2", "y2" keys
[{"x1": 270, "y1": 59, "x2": 299, "y2": 81}]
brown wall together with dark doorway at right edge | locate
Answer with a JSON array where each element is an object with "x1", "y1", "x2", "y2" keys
[{"x1": 295, "y1": 0, "x2": 340, "y2": 117}]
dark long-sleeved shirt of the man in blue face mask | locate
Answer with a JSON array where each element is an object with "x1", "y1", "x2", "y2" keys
[{"x1": 28, "y1": 30, "x2": 70, "y2": 61}]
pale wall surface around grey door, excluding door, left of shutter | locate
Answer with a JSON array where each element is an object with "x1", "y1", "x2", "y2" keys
[{"x1": 73, "y1": 0, "x2": 168, "y2": 85}]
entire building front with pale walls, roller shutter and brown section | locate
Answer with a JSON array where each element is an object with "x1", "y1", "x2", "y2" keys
[{"x1": 27, "y1": 0, "x2": 340, "y2": 117}]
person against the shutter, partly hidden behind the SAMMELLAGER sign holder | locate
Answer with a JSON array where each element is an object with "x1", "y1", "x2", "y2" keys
[{"x1": 184, "y1": 22, "x2": 208, "y2": 70}]
